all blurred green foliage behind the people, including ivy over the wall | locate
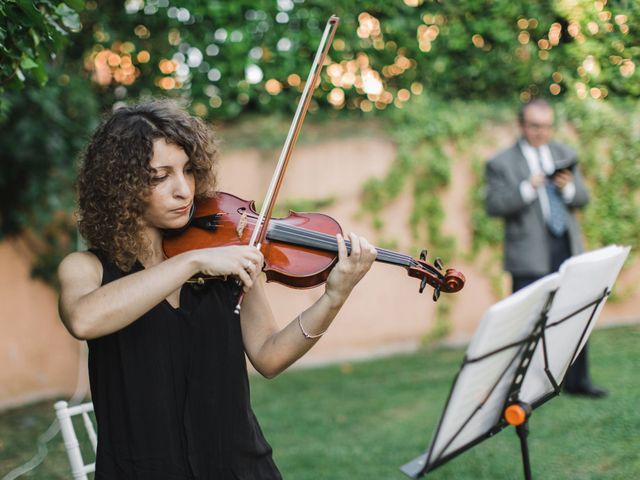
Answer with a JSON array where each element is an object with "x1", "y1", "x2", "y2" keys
[{"x1": 0, "y1": 0, "x2": 640, "y2": 284}]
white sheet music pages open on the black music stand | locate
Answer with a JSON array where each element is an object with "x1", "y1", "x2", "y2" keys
[{"x1": 410, "y1": 245, "x2": 630, "y2": 475}]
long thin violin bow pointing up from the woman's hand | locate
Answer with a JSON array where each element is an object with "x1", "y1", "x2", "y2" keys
[{"x1": 234, "y1": 15, "x2": 340, "y2": 315}]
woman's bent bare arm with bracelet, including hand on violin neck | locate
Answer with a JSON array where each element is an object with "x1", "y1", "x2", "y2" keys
[{"x1": 240, "y1": 233, "x2": 377, "y2": 378}]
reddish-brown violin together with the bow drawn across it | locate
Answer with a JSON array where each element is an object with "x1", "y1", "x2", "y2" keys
[{"x1": 163, "y1": 15, "x2": 465, "y2": 314}]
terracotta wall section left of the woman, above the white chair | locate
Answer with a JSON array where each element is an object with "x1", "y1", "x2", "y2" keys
[{"x1": 0, "y1": 240, "x2": 86, "y2": 410}]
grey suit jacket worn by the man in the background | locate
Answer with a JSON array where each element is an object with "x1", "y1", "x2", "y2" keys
[{"x1": 485, "y1": 142, "x2": 589, "y2": 276}]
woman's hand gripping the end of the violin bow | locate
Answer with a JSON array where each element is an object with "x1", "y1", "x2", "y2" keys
[{"x1": 189, "y1": 245, "x2": 264, "y2": 292}]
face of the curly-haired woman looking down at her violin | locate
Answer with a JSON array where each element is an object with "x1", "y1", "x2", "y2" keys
[{"x1": 144, "y1": 138, "x2": 196, "y2": 228}]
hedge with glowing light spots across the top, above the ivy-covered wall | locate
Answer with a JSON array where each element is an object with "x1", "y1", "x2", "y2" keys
[{"x1": 48, "y1": 0, "x2": 640, "y2": 119}]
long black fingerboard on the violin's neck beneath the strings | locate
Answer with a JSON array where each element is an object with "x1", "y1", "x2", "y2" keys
[{"x1": 267, "y1": 223, "x2": 414, "y2": 267}]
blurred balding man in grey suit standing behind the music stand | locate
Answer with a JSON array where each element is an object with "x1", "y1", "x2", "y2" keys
[{"x1": 485, "y1": 99, "x2": 607, "y2": 398}]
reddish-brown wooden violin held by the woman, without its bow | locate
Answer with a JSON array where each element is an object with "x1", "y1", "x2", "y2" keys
[{"x1": 163, "y1": 192, "x2": 465, "y2": 301}]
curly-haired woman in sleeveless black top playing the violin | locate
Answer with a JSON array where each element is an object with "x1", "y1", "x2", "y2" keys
[{"x1": 59, "y1": 101, "x2": 376, "y2": 480}]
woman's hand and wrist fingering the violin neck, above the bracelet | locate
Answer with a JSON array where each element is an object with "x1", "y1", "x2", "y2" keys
[{"x1": 326, "y1": 233, "x2": 378, "y2": 305}]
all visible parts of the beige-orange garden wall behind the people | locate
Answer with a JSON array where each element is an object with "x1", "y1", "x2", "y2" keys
[{"x1": 0, "y1": 129, "x2": 640, "y2": 409}]
